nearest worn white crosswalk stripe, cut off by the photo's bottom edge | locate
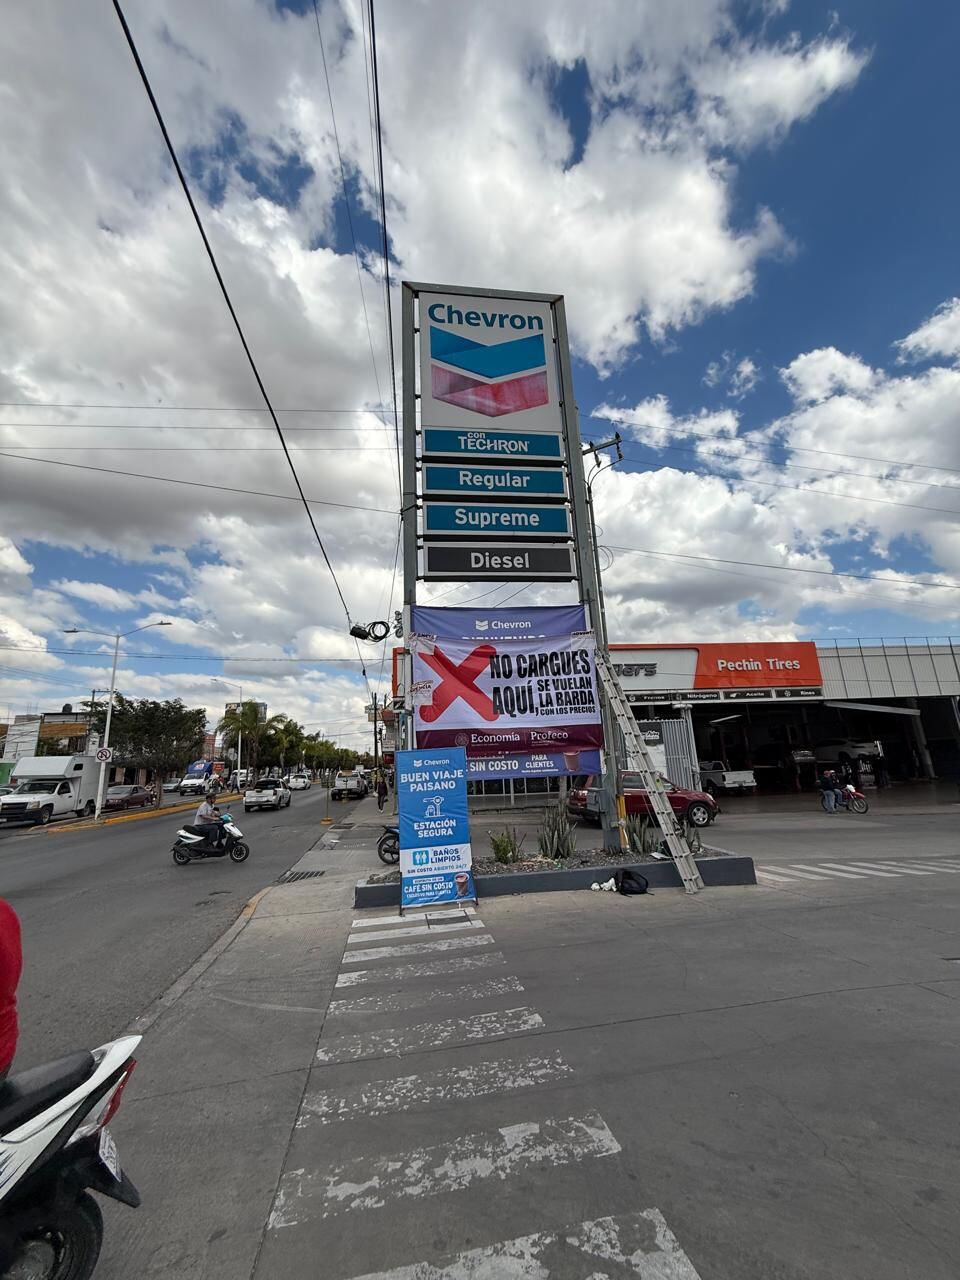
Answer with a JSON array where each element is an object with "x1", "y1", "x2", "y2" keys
[{"x1": 343, "y1": 1208, "x2": 700, "y2": 1280}]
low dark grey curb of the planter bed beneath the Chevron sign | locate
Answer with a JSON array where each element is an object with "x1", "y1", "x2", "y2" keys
[{"x1": 353, "y1": 856, "x2": 756, "y2": 909}]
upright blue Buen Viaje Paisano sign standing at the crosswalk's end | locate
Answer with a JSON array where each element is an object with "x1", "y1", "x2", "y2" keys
[{"x1": 394, "y1": 746, "x2": 476, "y2": 910}]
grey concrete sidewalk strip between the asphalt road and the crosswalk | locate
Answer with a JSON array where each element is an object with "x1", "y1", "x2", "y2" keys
[{"x1": 97, "y1": 800, "x2": 379, "y2": 1280}]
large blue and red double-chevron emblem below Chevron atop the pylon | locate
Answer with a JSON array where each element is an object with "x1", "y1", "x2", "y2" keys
[{"x1": 430, "y1": 325, "x2": 548, "y2": 417}]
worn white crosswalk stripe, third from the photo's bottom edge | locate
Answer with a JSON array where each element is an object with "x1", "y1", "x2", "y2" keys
[{"x1": 297, "y1": 1052, "x2": 573, "y2": 1129}]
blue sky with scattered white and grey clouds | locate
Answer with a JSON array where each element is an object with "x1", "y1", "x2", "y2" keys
[{"x1": 0, "y1": 0, "x2": 960, "y2": 746}]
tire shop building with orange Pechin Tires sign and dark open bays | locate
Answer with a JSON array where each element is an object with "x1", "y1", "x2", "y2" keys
[{"x1": 611, "y1": 637, "x2": 960, "y2": 791}]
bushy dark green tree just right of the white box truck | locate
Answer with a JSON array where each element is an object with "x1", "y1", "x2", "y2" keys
[{"x1": 87, "y1": 694, "x2": 206, "y2": 804}]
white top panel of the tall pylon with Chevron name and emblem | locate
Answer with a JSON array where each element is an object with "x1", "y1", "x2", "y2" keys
[{"x1": 420, "y1": 292, "x2": 561, "y2": 431}]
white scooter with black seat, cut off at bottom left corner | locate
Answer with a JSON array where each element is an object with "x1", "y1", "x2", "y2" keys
[{"x1": 0, "y1": 1036, "x2": 141, "y2": 1280}]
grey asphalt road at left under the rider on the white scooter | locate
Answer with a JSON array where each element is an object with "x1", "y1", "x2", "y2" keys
[{"x1": 0, "y1": 787, "x2": 337, "y2": 1069}]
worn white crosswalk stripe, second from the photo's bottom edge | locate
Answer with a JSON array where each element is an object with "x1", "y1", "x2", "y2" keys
[{"x1": 269, "y1": 1111, "x2": 621, "y2": 1228}]
